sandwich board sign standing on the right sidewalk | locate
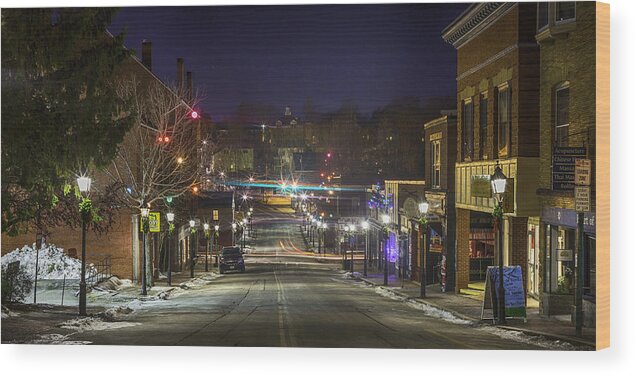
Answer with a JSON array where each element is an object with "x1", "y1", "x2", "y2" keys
[{"x1": 481, "y1": 266, "x2": 527, "y2": 321}]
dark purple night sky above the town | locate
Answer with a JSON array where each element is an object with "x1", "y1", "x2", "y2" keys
[{"x1": 110, "y1": 3, "x2": 467, "y2": 120}]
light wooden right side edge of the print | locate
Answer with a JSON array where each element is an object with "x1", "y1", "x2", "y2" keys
[{"x1": 595, "y1": 2, "x2": 611, "y2": 350}]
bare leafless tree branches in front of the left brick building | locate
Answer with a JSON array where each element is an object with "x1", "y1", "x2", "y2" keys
[{"x1": 106, "y1": 79, "x2": 201, "y2": 209}]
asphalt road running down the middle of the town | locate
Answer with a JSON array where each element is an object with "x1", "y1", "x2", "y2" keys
[{"x1": 63, "y1": 203, "x2": 539, "y2": 349}]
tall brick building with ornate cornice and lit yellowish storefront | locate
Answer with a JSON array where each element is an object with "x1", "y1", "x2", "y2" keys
[{"x1": 442, "y1": 3, "x2": 540, "y2": 291}]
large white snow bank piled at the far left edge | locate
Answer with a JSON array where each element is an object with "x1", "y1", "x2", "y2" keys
[{"x1": 1, "y1": 244, "x2": 93, "y2": 279}]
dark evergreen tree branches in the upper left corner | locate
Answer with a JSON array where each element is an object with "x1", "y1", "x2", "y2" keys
[{"x1": 2, "y1": 8, "x2": 132, "y2": 235}]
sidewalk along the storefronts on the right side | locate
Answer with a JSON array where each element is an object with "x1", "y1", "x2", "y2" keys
[{"x1": 355, "y1": 265, "x2": 595, "y2": 348}]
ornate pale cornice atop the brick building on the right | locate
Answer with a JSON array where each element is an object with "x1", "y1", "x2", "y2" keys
[{"x1": 441, "y1": 2, "x2": 518, "y2": 49}]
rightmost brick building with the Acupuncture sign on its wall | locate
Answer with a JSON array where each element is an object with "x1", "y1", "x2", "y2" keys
[{"x1": 540, "y1": 2, "x2": 597, "y2": 325}]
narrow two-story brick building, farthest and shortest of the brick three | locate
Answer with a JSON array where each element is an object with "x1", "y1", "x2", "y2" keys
[{"x1": 422, "y1": 111, "x2": 456, "y2": 291}]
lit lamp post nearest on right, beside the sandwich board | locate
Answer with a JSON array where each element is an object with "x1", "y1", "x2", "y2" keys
[{"x1": 490, "y1": 161, "x2": 507, "y2": 324}]
